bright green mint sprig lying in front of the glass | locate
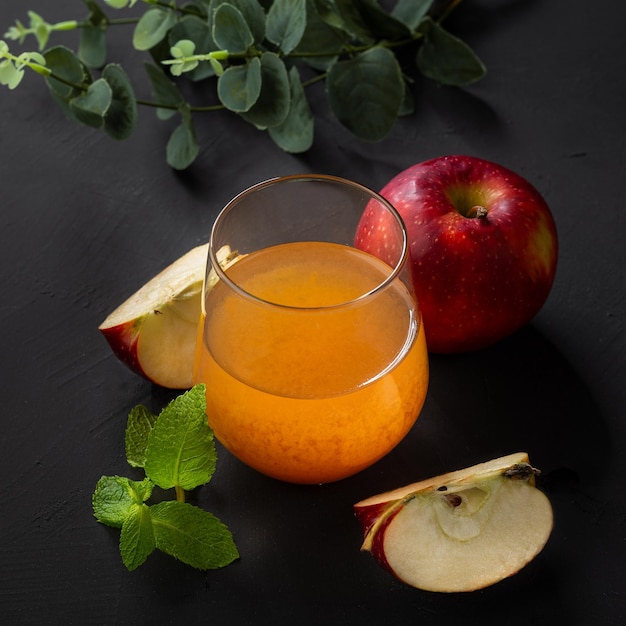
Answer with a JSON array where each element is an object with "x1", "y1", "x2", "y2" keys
[{"x1": 92, "y1": 385, "x2": 239, "y2": 570}]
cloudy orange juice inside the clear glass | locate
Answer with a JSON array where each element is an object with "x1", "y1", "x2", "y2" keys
[{"x1": 195, "y1": 242, "x2": 428, "y2": 483}]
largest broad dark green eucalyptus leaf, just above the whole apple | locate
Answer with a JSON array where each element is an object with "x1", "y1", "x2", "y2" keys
[{"x1": 327, "y1": 47, "x2": 404, "y2": 141}]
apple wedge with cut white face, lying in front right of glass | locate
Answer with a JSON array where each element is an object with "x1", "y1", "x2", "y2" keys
[{"x1": 354, "y1": 452, "x2": 553, "y2": 592}]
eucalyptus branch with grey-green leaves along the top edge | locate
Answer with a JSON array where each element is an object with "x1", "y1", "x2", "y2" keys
[{"x1": 0, "y1": 0, "x2": 486, "y2": 169}]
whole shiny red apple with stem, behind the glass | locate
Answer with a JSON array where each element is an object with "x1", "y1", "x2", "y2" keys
[{"x1": 355, "y1": 155, "x2": 558, "y2": 353}]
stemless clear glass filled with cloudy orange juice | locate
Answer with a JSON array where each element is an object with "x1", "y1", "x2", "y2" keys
[{"x1": 194, "y1": 175, "x2": 428, "y2": 484}]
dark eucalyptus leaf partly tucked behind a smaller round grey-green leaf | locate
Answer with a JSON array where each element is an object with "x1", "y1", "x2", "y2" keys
[{"x1": 241, "y1": 52, "x2": 291, "y2": 129}]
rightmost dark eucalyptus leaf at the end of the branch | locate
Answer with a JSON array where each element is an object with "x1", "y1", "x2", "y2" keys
[{"x1": 417, "y1": 18, "x2": 486, "y2": 86}]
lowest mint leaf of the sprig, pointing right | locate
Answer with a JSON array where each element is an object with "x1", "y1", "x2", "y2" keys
[{"x1": 150, "y1": 501, "x2": 239, "y2": 570}]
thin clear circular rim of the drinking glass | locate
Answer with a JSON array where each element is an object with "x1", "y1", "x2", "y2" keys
[{"x1": 203, "y1": 174, "x2": 409, "y2": 311}]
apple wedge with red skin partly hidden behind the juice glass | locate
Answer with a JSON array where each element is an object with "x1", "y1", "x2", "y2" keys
[{"x1": 98, "y1": 244, "x2": 238, "y2": 389}]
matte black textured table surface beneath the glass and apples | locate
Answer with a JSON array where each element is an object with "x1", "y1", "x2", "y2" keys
[{"x1": 0, "y1": 0, "x2": 626, "y2": 625}]
